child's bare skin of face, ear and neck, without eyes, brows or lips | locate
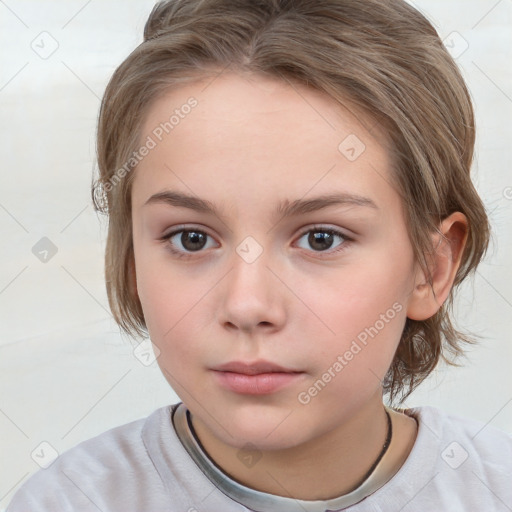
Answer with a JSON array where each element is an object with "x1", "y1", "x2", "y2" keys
[{"x1": 132, "y1": 73, "x2": 467, "y2": 500}]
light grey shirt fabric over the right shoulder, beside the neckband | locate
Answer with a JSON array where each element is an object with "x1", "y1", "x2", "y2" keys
[{"x1": 360, "y1": 406, "x2": 512, "y2": 512}]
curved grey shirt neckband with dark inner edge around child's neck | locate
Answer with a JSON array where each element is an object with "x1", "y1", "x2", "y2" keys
[{"x1": 172, "y1": 403, "x2": 402, "y2": 512}]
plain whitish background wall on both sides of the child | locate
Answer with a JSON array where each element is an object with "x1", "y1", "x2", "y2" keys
[{"x1": 0, "y1": 0, "x2": 512, "y2": 509}]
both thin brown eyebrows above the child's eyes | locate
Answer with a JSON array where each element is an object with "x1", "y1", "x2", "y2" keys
[{"x1": 143, "y1": 190, "x2": 379, "y2": 218}]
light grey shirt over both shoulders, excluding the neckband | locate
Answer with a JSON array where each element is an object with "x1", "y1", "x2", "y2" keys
[{"x1": 7, "y1": 404, "x2": 512, "y2": 512}]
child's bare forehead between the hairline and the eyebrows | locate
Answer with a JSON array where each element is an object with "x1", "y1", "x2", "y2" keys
[{"x1": 132, "y1": 73, "x2": 393, "y2": 218}]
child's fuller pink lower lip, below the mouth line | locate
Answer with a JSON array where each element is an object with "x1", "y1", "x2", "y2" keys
[{"x1": 215, "y1": 371, "x2": 301, "y2": 395}]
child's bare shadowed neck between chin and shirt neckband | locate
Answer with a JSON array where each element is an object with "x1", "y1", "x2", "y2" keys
[{"x1": 188, "y1": 396, "x2": 416, "y2": 500}]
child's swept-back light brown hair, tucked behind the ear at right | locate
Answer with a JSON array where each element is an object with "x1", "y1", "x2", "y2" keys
[{"x1": 92, "y1": 0, "x2": 490, "y2": 402}]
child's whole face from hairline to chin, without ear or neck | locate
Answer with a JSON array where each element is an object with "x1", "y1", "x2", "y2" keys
[{"x1": 132, "y1": 70, "x2": 416, "y2": 449}]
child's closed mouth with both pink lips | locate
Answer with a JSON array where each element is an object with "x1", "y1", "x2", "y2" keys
[{"x1": 213, "y1": 361, "x2": 304, "y2": 395}]
